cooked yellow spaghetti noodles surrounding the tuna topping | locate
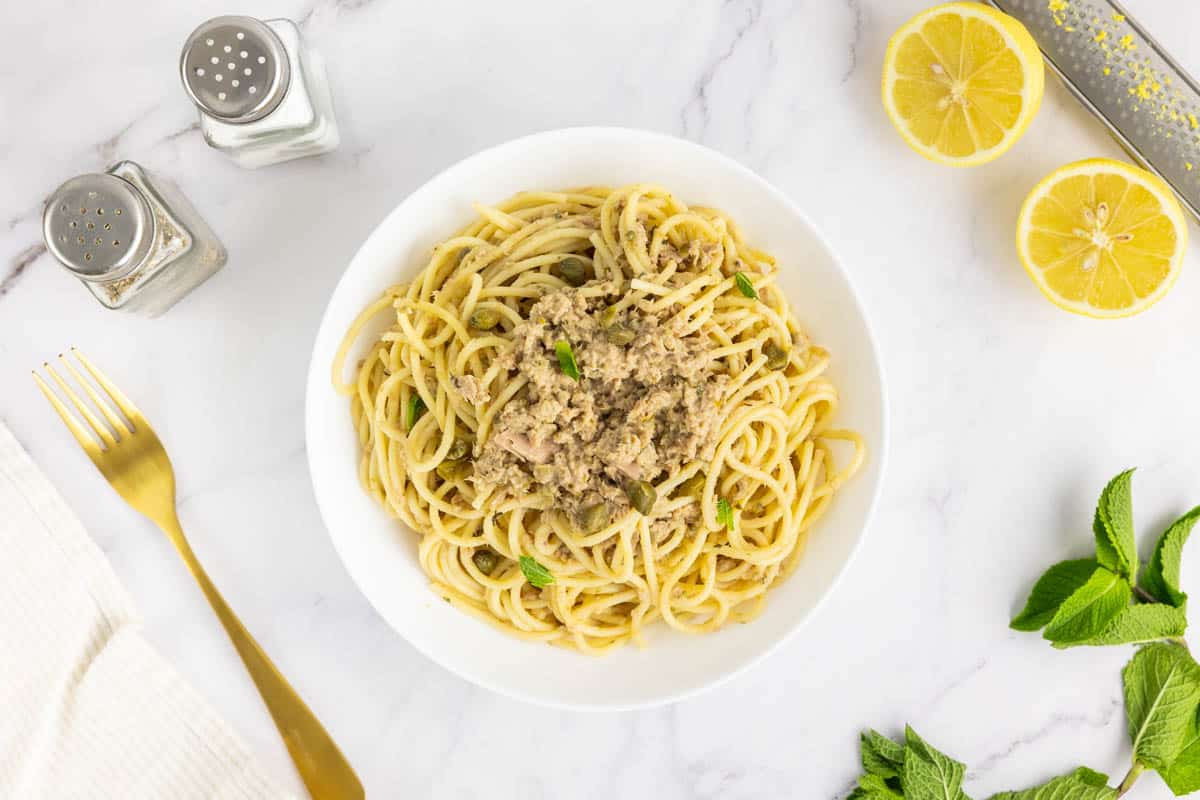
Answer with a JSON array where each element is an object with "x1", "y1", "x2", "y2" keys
[{"x1": 334, "y1": 185, "x2": 865, "y2": 652}]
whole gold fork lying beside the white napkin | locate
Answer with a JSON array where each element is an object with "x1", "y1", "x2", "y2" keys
[{"x1": 34, "y1": 348, "x2": 365, "y2": 800}]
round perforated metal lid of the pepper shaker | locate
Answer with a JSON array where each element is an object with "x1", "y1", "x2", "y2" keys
[{"x1": 42, "y1": 173, "x2": 155, "y2": 281}]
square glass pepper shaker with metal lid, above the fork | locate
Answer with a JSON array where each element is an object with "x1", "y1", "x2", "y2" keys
[{"x1": 42, "y1": 161, "x2": 226, "y2": 317}]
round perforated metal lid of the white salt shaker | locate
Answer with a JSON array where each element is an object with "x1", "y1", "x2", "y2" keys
[{"x1": 179, "y1": 17, "x2": 292, "y2": 124}]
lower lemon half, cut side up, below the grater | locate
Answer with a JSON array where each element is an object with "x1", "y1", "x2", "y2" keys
[{"x1": 1016, "y1": 158, "x2": 1188, "y2": 318}]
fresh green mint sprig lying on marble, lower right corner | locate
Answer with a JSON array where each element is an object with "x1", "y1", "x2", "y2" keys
[{"x1": 847, "y1": 470, "x2": 1200, "y2": 800}]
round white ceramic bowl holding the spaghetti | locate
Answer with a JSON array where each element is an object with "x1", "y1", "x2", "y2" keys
[{"x1": 306, "y1": 128, "x2": 887, "y2": 709}]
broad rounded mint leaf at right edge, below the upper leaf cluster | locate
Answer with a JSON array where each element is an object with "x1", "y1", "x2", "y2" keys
[{"x1": 1121, "y1": 643, "x2": 1200, "y2": 771}]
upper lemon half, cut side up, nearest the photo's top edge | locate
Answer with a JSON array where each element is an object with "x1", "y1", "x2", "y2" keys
[{"x1": 883, "y1": 2, "x2": 1045, "y2": 167}]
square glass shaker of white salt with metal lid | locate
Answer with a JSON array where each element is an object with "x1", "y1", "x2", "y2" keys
[{"x1": 179, "y1": 17, "x2": 338, "y2": 168}]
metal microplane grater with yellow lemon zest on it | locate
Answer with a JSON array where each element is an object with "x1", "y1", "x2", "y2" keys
[{"x1": 988, "y1": 0, "x2": 1200, "y2": 218}]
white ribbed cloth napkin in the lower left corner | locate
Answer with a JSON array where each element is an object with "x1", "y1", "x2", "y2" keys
[{"x1": 0, "y1": 422, "x2": 288, "y2": 800}]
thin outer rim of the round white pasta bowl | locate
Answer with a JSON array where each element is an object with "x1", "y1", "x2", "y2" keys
[{"x1": 304, "y1": 125, "x2": 890, "y2": 712}]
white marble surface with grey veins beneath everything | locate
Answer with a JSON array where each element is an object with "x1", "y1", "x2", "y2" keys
[{"x1": 7, "y1": 0, "x2": 1200, "y2": 800}]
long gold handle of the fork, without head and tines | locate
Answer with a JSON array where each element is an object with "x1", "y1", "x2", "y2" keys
[{"x1": 155, "y1": 515, "x2": 366, "y2": 800}]
